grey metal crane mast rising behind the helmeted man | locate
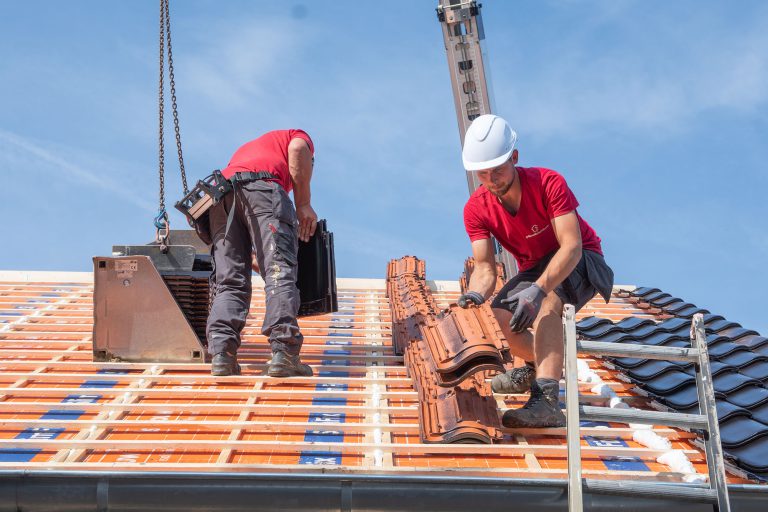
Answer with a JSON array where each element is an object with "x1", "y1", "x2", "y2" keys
[{"x1": 437, "y1": 0, "x2": 517, "y2": 279}]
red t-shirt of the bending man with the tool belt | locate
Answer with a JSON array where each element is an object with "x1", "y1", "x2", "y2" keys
[{"x1": 221, "y1": 130, "x2": 315, "y2": 192}]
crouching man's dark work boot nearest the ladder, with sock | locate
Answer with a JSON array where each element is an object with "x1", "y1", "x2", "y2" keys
[{"x1": 501, "y1": 379, "x2": 565, "y2": 428}]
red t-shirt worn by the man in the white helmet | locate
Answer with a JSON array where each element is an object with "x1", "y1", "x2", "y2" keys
[{"x1": 464, "y1": 167, "x2": 603, "y2": 271}]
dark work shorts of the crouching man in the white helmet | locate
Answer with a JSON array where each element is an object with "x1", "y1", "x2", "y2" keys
[{"x1": 491, "y1": 250, "x2": 613, "y2": 311}]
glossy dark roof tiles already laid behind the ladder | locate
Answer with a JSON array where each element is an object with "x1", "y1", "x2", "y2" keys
[{"x1": 578, "y1": 288, "x2": 768, "y2": 481}]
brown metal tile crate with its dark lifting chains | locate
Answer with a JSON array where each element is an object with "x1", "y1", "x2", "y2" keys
[{"x1": 93, "y1": 0, "x2": 212, "y2": 362}]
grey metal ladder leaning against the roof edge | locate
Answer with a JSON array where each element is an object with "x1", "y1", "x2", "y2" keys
[{"x1": 563, "y1": 304, "x2": 730, "y2": 512}]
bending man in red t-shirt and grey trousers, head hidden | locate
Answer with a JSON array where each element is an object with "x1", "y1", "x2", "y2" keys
[{"x1": 207, "y1": 130, "x2": 317, "y2": 377}]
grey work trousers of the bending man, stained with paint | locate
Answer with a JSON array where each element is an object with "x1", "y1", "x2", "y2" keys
[{"x1": 206, "y1": 180, "x2": 304, "y2": 355}]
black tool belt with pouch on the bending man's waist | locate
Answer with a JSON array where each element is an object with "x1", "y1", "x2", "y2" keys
[{"x1": 175, "y1": 169, "x2": 277, "y2": 245}]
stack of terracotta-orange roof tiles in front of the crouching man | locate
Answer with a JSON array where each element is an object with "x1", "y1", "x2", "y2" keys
[{"x1": 387, "y1": 256, "x2": 511, "y2": 443}]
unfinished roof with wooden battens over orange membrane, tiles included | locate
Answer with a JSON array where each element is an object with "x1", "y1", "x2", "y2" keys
[{"x1": 0, "y1": 258, "x2": 768, "y2": 510}]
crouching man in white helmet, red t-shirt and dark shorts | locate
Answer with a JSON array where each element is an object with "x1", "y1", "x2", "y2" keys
[{"x1": 458, "y1": 115, "x2": 613, "y2": 428}]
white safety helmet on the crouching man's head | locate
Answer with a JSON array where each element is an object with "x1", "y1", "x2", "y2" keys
[{"x1": 461, "y1": 114, "x2": 517, "y2": 171}]
